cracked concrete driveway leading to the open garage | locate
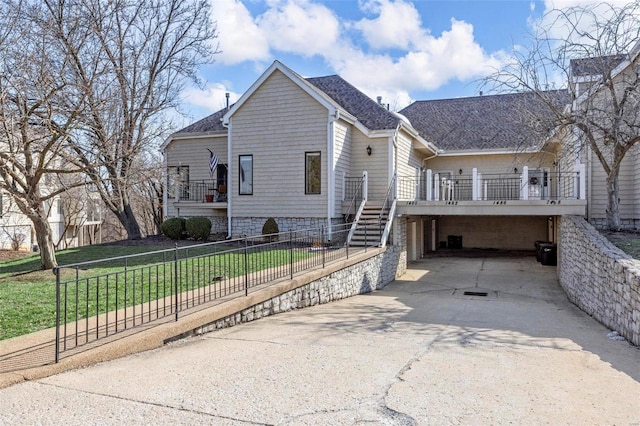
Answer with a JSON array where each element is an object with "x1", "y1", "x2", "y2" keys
[{"x1": 0, "y1": 258, "x2": 640, "y2": 425}]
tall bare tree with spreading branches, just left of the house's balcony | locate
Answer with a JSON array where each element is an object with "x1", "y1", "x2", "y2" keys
[{"x1": 42, "y1": 0, "x2": 216, "y2": 239}]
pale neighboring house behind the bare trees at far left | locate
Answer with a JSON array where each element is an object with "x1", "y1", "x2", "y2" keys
[{"x1": 0, "y1": 186, "x2": 102, "y2": 250}]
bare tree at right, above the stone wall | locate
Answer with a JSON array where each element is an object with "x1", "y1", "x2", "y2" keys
[{"x1": 485, "y1": 2, "x2": 640, "y2": 229}]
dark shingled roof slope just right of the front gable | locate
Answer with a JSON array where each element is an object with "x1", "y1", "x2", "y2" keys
[{"x1": 306, "y1": 75, "x2": 400, "y2": 130}]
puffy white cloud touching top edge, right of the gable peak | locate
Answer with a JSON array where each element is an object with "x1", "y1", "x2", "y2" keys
[{"x1": 353, "y1": 0, "x2": 427, "y2": 49}]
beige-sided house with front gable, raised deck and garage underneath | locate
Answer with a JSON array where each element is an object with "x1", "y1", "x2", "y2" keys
[{"x1": 162, "y1": 61, "x2": 586, "y2": 266}]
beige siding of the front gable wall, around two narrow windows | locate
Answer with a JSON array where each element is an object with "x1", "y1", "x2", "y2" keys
[{"x1": 230, "y1": 71, "x2": 328, "y2": 218}]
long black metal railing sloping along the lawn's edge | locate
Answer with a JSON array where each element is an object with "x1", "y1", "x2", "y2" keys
[{"x1": 54, "y1": 223, "x2": 379, "y2": 362}]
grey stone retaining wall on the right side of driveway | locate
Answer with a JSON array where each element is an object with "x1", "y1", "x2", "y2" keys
[{"x1": 558, "y1": 216, "x2": 640, "y2": 345}]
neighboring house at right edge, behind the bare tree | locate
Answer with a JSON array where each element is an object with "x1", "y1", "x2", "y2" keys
[{"x1": 565, "y1": 42, "x2": 640, "y2": 229}]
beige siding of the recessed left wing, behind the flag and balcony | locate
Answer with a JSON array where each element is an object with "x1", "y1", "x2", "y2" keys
[{"x1": 165, "y1": 134, "x2": 227, "y2": 217}]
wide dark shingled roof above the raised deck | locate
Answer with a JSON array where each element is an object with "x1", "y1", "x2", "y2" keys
[{"x1": 400, "y1": 90, "x2": 569, "y2": 151}]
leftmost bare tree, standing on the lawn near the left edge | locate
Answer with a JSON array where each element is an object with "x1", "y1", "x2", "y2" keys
[{"x1": 0, "y1": 2, "x2": 90, "y2": 269}]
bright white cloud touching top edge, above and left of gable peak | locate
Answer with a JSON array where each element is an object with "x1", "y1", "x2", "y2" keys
[{"x1": 211, "y1": 0, "x2": 270, "y2": 65}]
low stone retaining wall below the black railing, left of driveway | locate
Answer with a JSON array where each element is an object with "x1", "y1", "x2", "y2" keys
[{"x1": 194, "y1": 246, "x2": 406, "y2": 334}]
